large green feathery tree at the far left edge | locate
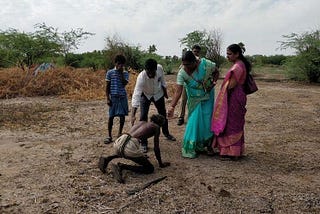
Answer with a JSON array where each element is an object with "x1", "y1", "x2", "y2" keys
[{"x1": 0, "y1": 23, "x2": 93, "y2": 70}]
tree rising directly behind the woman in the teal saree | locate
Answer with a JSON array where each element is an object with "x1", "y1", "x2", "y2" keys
[{"x1": 179, "y1": 29, "x2": 224, "y2": 67}]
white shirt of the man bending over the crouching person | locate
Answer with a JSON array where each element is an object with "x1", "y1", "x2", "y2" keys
[{"x1": 132, "y1": 64, "x2": 167, "y2": 108}]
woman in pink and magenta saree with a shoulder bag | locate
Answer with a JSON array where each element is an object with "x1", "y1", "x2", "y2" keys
[{"x1": 211, "y1": 44, "x2": 251, "y2": 159}]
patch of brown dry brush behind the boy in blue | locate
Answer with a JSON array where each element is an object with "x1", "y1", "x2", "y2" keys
[{"x1": 0, "y1": 67, "x2": 137, "y2": 100}]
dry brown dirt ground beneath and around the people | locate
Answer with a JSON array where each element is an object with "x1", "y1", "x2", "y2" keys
[{"x1": 0, "y1": 76, "x2": 320, "y2": 213}]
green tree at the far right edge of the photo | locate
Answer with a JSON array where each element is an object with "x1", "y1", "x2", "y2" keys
[{"x1": 280, "y1": 30, "x2": 320, "y2": 82}]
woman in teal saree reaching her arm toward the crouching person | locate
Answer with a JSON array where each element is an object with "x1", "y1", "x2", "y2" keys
[{"x1": 168, "y1": 51, "x2": 218, "y2": 158}]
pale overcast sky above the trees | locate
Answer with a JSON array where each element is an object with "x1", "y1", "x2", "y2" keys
[{"x1": 0, "y1": 0, "x2": 320, "y2": 56}]
